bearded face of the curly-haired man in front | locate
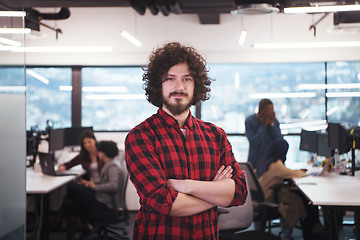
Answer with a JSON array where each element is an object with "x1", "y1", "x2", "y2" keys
[{"x1": 162, "y1": 63, "x2": 195, "y2": 115}]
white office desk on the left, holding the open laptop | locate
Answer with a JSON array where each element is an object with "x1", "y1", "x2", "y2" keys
[{"x1": 26, "y1": 165, "x2": 85, "y2": 240}]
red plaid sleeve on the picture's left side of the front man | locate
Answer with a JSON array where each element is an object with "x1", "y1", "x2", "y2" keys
[{"x1": 125, "y1": 128, "x2": 177, "y2": 215}]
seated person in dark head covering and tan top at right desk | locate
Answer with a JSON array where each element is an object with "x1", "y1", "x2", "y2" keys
[{"x1": 256, "y1": 139, "x2": 321, "y2": 240}]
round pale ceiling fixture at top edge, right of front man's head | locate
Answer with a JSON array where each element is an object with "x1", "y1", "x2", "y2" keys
[{"x1": 231, "y1": 0, "x2": 280, "y2": 15}]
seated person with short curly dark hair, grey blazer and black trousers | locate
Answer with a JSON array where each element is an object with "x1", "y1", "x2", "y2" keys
[{"x1": 65, "y1": 141, "x2": 122, "y2": 240}]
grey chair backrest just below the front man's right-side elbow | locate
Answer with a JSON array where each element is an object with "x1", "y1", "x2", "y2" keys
[{"x1": 219, "y1": 174, "x2": 254, "y2": 231}]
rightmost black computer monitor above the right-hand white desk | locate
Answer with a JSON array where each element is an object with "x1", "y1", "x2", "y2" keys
[{"x1": 328, "y1": 123, "x2": 350, "y2": 154}]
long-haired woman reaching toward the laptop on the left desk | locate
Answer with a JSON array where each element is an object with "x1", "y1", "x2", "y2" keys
[{"x1": 57, "y1": 130, "x2": 104, "y2": 180}]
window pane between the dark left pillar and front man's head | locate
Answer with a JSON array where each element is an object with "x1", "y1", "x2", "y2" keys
[{"x1": 82, "y1": 67, "x2": 157, "y2": 131}]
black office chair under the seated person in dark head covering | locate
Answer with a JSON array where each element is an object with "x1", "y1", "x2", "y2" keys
[{"x1": 239, "y1": 162, "x2": 281, "y2": 232}]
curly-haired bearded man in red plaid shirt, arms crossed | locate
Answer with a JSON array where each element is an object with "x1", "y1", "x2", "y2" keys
[{"x1": 125, "y1": 42, "x2": 247, "y2": 240}]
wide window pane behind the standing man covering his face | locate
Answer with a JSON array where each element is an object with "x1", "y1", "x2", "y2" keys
[{"x1": 202, "y1": 63, "x2": 325, "y2": 133}]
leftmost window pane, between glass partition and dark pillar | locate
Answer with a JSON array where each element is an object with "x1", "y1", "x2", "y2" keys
[{"x1": 26, "y1": 67, "x2": 71, "y2": 130}]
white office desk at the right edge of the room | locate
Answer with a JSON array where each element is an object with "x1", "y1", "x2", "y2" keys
[{"x1": 293, "y1": 173, "x2": 360, "y2": 239}]
